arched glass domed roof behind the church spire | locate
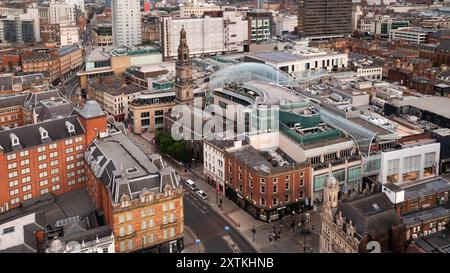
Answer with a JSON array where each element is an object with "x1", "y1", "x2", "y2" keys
[{"x1": 209, "y1": 63, "x2": 298, "y2": 90}]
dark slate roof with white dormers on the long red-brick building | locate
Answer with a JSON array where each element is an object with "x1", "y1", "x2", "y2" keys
[{"x1": 0, "y1": 116, "x2": 85, "y2": 153}]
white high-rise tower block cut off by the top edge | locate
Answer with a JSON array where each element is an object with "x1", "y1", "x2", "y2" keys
[{"x1": 111, "y1": 0, "x2": 142, "y2": 46}]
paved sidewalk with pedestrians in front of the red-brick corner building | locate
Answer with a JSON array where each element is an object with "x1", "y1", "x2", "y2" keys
[{"x1": 182, "y1": 165, "x2": 320, "y2": 253}]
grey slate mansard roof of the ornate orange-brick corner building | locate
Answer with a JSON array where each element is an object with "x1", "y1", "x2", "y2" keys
[{"x1": 85, "y1": 131, "x2": 179, "y2": 204}]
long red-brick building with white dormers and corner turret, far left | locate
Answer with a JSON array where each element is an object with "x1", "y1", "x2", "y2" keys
[{"x1": 0, "y1": 100, "x2": 106, "y2": 211}]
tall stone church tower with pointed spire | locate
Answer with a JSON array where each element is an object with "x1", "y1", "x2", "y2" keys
[{"x1": 175, "y1": 26, "x2": 194, "y2": 106}]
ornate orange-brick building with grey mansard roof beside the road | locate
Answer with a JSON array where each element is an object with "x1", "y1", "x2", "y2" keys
[{"x1": 85, "y1": 131, "x2": 184, "y2": 252}]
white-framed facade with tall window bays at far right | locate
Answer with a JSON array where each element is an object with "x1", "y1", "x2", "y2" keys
[{"x1": 378, "y1": 140, "x2": 441, "y2": 184}]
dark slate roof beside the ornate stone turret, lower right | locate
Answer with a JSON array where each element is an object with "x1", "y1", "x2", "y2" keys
[{"x1": 338, "y1": 193, "x2": 401, "y2": 237}]
